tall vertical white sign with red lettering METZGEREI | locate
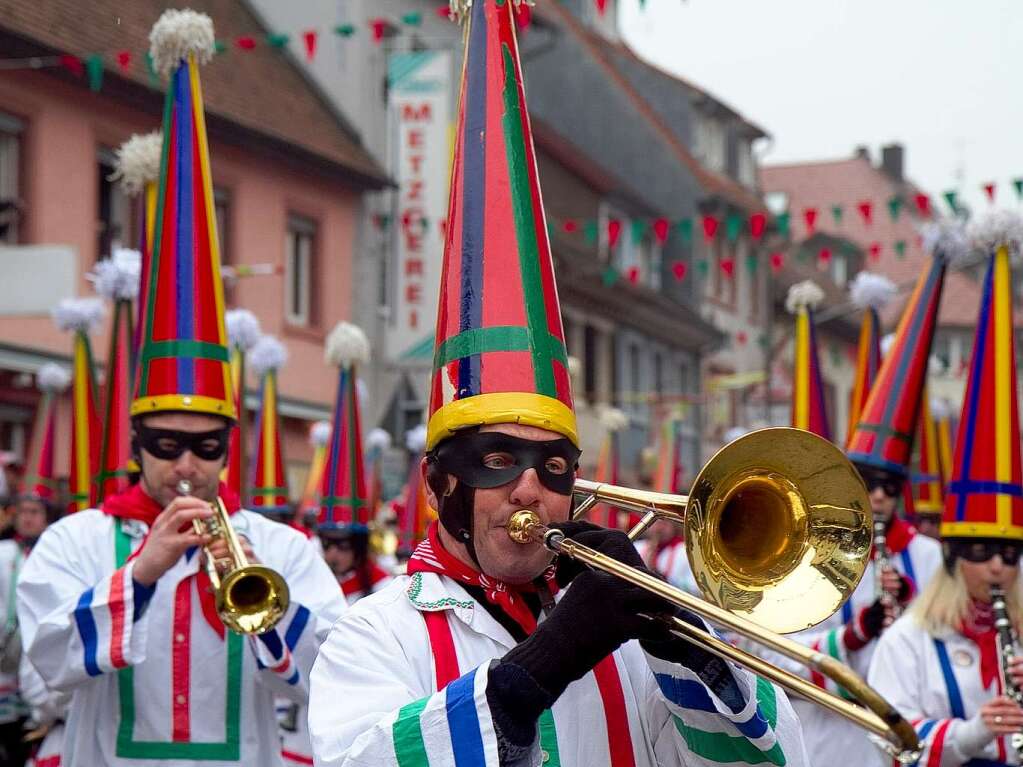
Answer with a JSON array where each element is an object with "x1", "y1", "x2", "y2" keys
[{"x1": 387, "y1": 51, "x2": 452, "y2": 363}]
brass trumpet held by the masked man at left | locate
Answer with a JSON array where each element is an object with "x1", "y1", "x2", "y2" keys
[{"x1": 177, "y1": 480, "x2": 290, "y2": 634}]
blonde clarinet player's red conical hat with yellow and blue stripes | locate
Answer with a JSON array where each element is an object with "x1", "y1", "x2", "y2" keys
[{"x1": 941, "y1": 212, "x2": 1023, "y2": 541}]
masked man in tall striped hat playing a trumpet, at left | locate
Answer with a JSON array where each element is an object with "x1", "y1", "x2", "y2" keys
[{"x1": 17, "y1": 11, "x2": 344, "y2": 767}]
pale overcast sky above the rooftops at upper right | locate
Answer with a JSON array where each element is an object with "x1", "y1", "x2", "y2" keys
[{"x1": 618, "y1": 0, "x2": 1023, "y2": 211}]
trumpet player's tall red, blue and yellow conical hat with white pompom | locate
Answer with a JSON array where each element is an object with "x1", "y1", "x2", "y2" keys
[{"x1": 131, "y1": 10, "x2": 235, "y2": 420}]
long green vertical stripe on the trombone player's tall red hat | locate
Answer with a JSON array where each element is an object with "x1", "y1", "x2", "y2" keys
[{"x1": 502, "y1": 46, "x2": 564, "y2": 399}]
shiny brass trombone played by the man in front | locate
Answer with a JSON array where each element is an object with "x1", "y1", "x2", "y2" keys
[{"x1": 507, "y1": 428, "x2": 920, "y2": 764}]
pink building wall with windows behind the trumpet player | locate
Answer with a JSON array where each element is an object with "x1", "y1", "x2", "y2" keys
[{"x1": 0, "y1": 72, "x2": 360, "y2": 482}]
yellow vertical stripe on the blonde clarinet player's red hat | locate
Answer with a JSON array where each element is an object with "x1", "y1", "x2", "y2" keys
[{"x1": 992, "y1": 245, "x2": 1019, "y2": 525}]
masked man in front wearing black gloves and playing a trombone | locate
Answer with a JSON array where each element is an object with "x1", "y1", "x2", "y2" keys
[{"x1": 309, "y1": 0, "x2": 806, "y2": 767}]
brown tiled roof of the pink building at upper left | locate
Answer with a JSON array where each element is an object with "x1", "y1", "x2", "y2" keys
[{"x1": 0, "y1": 0, "x2": 387, "y2": 187}]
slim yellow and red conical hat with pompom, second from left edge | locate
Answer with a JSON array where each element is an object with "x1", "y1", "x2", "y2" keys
[{"x1": 53, "y1": 299, "x2": 103, "y2": 512}]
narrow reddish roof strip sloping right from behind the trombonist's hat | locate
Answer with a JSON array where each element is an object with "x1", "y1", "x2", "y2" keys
[{"x1": 534, "y1": 3, "x2": 763, "y2": 211}]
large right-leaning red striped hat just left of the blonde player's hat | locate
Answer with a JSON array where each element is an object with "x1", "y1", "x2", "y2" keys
[{"x1": 846, "y1": 222, "x2": 967, "y2": 479}]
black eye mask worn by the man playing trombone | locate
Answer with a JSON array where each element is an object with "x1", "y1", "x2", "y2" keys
[{"x1": 436, "y1": 432, "x2": 580, "y2": 495}]
